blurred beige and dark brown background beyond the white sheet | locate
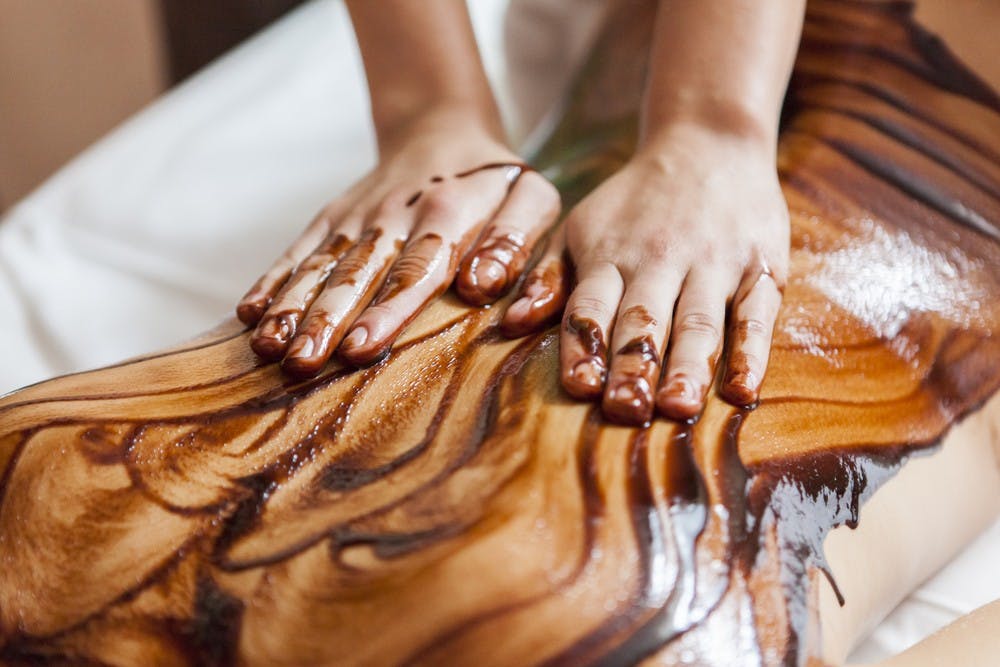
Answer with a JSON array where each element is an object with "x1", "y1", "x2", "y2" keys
[{"x1": 0, "y1": 0, "x2": 304, "y2": 212}]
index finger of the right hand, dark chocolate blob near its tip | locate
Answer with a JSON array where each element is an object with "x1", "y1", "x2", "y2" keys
[{"x1": 559, "y1": 262, "x2": 624, "y2": 400}]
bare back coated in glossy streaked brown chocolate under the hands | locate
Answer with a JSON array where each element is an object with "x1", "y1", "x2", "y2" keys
[{"x1": 0, "y1": 0, "x2": 1000, "y2": 667}]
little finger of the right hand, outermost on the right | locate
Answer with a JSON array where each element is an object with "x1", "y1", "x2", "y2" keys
[{"x1": 721, "y1": 272, "x2": 781, "y2": 407}]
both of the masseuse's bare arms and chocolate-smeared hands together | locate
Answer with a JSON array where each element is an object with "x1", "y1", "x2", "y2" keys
[{"x1": 237, "y1": 0, "x2": 804, "y2": 424}]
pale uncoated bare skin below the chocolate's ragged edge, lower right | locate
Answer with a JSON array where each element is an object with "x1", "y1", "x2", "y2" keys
[{"x1": 817, "y1": 396, "x2": 1000, "y2": 667}]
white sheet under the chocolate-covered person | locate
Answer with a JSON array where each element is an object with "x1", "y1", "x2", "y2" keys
[{"x1": 0, "y1": 0, "x2": 1000, "y2": 660}]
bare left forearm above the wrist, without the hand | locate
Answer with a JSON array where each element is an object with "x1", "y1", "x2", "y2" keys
[{"x1": 347, "y1": 0, "x2": 502, "y2": 148}]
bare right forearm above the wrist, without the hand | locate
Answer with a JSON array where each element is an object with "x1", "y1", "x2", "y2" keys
[{"x1": 641, "y1": 0, "x2": 805, "y2": 150}]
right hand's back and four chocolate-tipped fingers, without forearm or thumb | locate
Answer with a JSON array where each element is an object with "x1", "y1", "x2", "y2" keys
[{"x1": 548, "y1": 125, "x2": 789, "y2": 424}]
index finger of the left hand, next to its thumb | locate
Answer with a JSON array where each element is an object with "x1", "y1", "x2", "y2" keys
[{"x1": 340, "y1": 179, "x2": 506, "y2": 365}]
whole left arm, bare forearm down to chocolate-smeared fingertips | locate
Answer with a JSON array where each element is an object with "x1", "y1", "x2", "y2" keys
[{"x1": 237, "y1": 0, "x2": 559, "y2": 376}]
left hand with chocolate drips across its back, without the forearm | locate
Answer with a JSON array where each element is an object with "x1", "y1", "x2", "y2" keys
[{"x1": 236, "y1": 114, "x2": 560, "y2": 376}]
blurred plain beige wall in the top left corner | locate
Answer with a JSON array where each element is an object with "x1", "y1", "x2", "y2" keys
[{"x1": 0, "y1": 0, "x2": 165, "y2": 210}]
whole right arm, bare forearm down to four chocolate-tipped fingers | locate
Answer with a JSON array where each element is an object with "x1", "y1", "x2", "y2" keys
[{"x1": 505, "y1": 0, "x2": 805, "y2": 424}]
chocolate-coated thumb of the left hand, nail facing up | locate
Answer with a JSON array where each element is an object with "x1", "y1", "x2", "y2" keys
[{"x1": 455, "y1": 172, "x2": 561, "y2": 306}]
